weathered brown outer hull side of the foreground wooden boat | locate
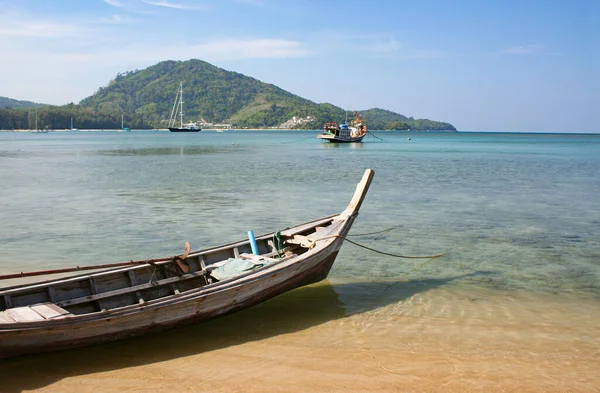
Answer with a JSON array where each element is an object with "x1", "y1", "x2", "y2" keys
[{"x1": 0, "y1": 240, "x2": 342, "y2": 359}]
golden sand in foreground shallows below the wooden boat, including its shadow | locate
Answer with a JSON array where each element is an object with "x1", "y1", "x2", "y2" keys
[{"x1": 0, "y1": 282, "x2": 600, "y2": 393}]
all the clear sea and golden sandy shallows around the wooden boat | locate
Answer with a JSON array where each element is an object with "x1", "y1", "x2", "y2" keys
[{"x1": 0, "y1": 132, "x2": 600, "y2": 393}]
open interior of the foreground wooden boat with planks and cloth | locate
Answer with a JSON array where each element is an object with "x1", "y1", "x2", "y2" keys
[{"x1": 0, "y1": 216, "x2": 339, "y2": 324}]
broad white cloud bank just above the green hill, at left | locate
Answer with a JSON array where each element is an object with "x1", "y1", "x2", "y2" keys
[{"x1": 0, "y1": 38, "x2": 312, "y2": 105}]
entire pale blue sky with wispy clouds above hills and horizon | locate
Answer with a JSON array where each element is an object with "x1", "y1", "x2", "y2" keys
[{"x1": 0, "y1": 0, "x2": 600, "y2": 133}]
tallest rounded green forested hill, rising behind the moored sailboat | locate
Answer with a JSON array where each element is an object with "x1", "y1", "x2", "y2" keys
[{"x1": 80, "y1": 60, "x2": 339, "y2": 127}]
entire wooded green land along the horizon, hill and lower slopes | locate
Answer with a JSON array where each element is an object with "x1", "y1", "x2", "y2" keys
[{"x1": 0, "y1": 60, "x2": 455, "y2": 130}]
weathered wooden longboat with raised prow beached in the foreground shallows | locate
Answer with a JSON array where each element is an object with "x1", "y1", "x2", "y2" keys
[{"x1": 0, "y1": 169, "x2": 374, "y2": 358}]
